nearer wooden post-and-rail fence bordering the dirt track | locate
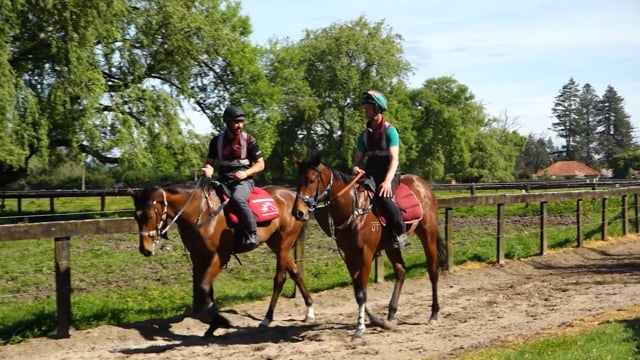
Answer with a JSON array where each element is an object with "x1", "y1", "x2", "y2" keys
[{"x1": 0, "y1": 186, "x2": 640, "y2": 337}]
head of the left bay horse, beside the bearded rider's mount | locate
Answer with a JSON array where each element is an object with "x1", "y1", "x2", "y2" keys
[{"x1": 129, "y1": 186, "x2": 168, "y2": 256}]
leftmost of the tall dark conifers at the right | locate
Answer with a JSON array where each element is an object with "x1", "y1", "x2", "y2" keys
[{"x1": 551, "y1": 78, "x2": 580, "y2": 160}]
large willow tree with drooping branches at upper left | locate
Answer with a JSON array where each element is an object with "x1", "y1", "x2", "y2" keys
[{"x1": 0, "y1": 0, "x2": 269, "y2": 184}]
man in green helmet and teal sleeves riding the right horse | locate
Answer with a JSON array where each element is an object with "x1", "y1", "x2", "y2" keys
[{"x1": 353, "y1": 90, "x2": 407, "y2": 248}]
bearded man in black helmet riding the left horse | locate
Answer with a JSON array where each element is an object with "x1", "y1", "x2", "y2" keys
[{"x1": 202, "y1": 106, "x2": 264, "y2": 252}]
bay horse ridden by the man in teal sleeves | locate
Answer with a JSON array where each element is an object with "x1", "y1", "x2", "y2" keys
[{"x1": 294, "y1": 154, "x2": 447, "y2": 338}]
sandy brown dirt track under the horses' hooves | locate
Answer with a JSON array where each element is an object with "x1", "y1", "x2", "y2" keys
[{"x1": 0, "y1": 236, "x2": 640, "y2": 359}]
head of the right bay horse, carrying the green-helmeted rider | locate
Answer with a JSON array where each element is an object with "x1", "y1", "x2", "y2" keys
[{"x1": 293, "y1": 154, "x2": 333, "y2": 220}]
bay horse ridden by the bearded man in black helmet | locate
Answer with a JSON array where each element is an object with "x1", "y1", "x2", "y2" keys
[{"x1": 129, "y1": 181, "x2": 315, "y2": 336}]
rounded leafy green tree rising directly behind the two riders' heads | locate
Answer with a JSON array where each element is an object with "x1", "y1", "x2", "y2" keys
[{"x1": 266, "y1": 17, "x2": 411, "y2": 177}]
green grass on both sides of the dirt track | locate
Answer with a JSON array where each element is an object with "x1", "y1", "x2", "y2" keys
[{"x1": 0, "y1": 191, "x2": 638, "y2": 359}]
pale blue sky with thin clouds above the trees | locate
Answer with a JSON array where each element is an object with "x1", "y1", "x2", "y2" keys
[{"x1": 190, "y1": 0, "x2": 640, "y2": 141}]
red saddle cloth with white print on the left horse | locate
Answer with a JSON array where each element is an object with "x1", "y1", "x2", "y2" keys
[{"x1": 215, "y1": 183, "x2": 280, "y2": 227}]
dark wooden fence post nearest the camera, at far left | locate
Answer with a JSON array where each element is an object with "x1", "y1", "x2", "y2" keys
[{"x1": 54, "y1": 236, "x2": 71, "y2": 338}]
